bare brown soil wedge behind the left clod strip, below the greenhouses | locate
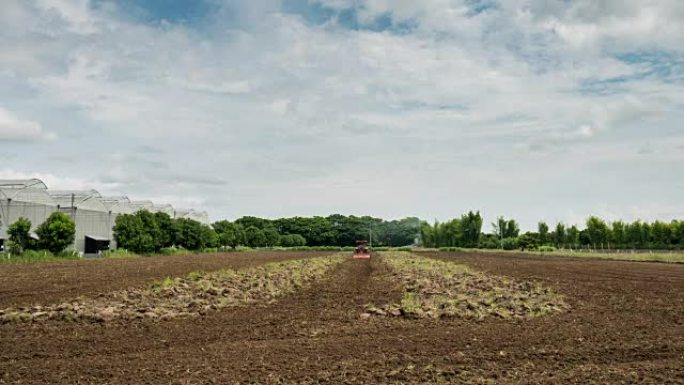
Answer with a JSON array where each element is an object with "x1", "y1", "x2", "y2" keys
[{"x1": 0, "y1": 252, "x2": 331, "y2": 309}]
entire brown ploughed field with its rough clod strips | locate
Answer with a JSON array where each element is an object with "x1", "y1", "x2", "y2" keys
[{"x1": 0, "y1": 252, "x2": 684, "y2": 384}]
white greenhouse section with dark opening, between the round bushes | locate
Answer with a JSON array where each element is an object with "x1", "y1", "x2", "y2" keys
[{"x1": 49, "y1": 190, "x2": 117, "y2": 254}]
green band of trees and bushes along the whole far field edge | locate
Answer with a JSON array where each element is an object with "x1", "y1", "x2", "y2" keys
[{"x1": 1, "y1": 210, "x2": 684, "y2": 259}]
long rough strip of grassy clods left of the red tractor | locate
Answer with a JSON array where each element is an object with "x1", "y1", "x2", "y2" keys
[{"x1": 0, "y1": 254, "x2": 348, "y2": 324}]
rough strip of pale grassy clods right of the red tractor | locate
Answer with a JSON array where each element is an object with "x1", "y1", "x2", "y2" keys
[{"x1": 362, "y1": 252, "x2": 569, "y2": 319}]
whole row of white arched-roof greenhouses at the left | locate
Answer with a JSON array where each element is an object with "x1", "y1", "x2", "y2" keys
[{"x1": 0, "y1": 179, "x2": 209, "y2": 254}]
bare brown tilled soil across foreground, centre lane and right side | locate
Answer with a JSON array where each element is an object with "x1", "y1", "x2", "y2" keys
[{"x1": 0, "y1": 253, "x2": 684, "y2": 384}]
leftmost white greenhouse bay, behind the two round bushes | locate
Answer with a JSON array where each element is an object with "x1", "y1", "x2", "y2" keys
[{"x1": 0, "y1": 179, "x2": 57, "y2": 250}]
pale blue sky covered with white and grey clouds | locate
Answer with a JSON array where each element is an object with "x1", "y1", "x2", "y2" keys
[{"x1": 0, "y1": 0, "x2": 684, "y2": 230}]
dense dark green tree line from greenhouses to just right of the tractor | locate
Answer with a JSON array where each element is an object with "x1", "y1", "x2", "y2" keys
[{"x1": 113, "y1": 210, "x2": 420, "y2": 253}]
